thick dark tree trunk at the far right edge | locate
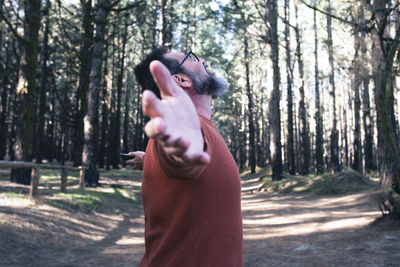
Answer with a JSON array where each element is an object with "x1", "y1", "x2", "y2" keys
[{"x1": 372, "y1": 1, "x2": 400, "y2": 193}]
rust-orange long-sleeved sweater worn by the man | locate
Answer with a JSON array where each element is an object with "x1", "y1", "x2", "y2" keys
[{"x1": 140, "y1": 116, "x2": 243, "y2": 267}]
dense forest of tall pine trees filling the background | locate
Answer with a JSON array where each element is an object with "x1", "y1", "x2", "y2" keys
[{"x1": 0, "y1": 0, "x2": 400, "y2": 205}]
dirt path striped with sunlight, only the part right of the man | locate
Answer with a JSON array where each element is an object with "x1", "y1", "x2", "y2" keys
[{"x1": 242, "y1": 179, "x2": 400, "y2": 267}]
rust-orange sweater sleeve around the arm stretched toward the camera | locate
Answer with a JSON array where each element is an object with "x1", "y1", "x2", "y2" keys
[{"x1": 154, "y1": 125, "x2": 212, "y2": 180}]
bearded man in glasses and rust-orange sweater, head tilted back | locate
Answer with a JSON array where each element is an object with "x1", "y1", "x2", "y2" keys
[{"x1": 135, "y1": 48, "x2": 243, "y2": 267}]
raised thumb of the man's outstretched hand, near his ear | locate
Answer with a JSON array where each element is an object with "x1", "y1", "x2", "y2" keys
[{"x1": 150, "y1": 60, "x2": 179, "y2": 96}]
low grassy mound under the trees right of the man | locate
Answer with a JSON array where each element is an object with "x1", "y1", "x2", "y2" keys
[{"x1": 260, "y1": 170, "x2": 379, "y2": 195}]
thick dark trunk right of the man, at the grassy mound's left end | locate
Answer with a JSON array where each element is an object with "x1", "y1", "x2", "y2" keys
[{"x1": 265, "y1": 0, "x2": 283, "y2": 181}]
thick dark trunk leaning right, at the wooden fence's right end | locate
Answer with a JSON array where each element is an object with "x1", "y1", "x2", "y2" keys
[{"x1": 82, "y1": 0, "x2": 109, "y2": 186}]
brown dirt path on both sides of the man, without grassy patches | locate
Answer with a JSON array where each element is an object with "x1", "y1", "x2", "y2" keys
[{"x1": 0, "y1": 173, "x2": 400, "y2": 267}]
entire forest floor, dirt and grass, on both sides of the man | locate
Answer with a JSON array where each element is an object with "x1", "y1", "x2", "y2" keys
[{"x1": 0, "y1": 169, "x2": 400, "y2": 267}]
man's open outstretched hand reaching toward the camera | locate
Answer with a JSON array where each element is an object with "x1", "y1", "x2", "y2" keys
[{"x1": 142, "y1": 61, "x2": 210, "y2": 165}]
